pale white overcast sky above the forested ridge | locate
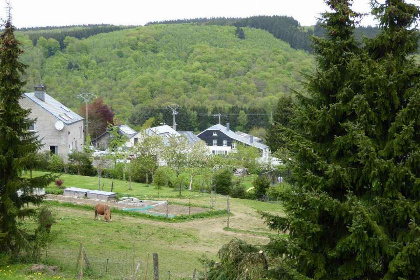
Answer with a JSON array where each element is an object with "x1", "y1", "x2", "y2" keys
[{"x1": 0, "y1": 0, "x2": 419, "y2": 28}]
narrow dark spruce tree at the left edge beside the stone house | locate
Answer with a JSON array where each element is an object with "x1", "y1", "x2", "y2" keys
[{"x1": 0, "y1": 16, "x2": 52, "y2": 257}]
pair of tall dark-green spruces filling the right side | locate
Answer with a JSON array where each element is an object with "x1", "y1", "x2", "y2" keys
[{"x1": 265, "y1": 0, "x2": 420, "y2": 280}]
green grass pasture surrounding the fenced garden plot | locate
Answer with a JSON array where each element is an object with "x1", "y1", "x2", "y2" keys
[{"x1": 4, "y1": 173, "x2": 282, "y2": 279}]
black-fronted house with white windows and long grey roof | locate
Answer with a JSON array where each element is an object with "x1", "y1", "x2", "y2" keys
[{"x1": 197, "y1": 123, "x2": 270, "y2": 160}]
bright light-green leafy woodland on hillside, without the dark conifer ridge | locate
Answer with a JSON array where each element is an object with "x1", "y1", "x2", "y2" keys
[{"x1": 16, "y1": 24, "x2": 313, "y2": 122}]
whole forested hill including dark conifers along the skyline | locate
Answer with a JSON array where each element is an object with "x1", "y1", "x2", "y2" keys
[{"x1": 17, "y1": 16, "x2": 416, "y2": 131}]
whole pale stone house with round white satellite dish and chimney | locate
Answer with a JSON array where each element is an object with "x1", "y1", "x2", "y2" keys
[{"x1": 19, "y1": 85, "x2": 85, "y2": 161}]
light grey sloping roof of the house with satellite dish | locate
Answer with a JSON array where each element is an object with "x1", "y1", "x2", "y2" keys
[{"x1": 23, "y1": 92, "x2": 83, "y2": 125}]
